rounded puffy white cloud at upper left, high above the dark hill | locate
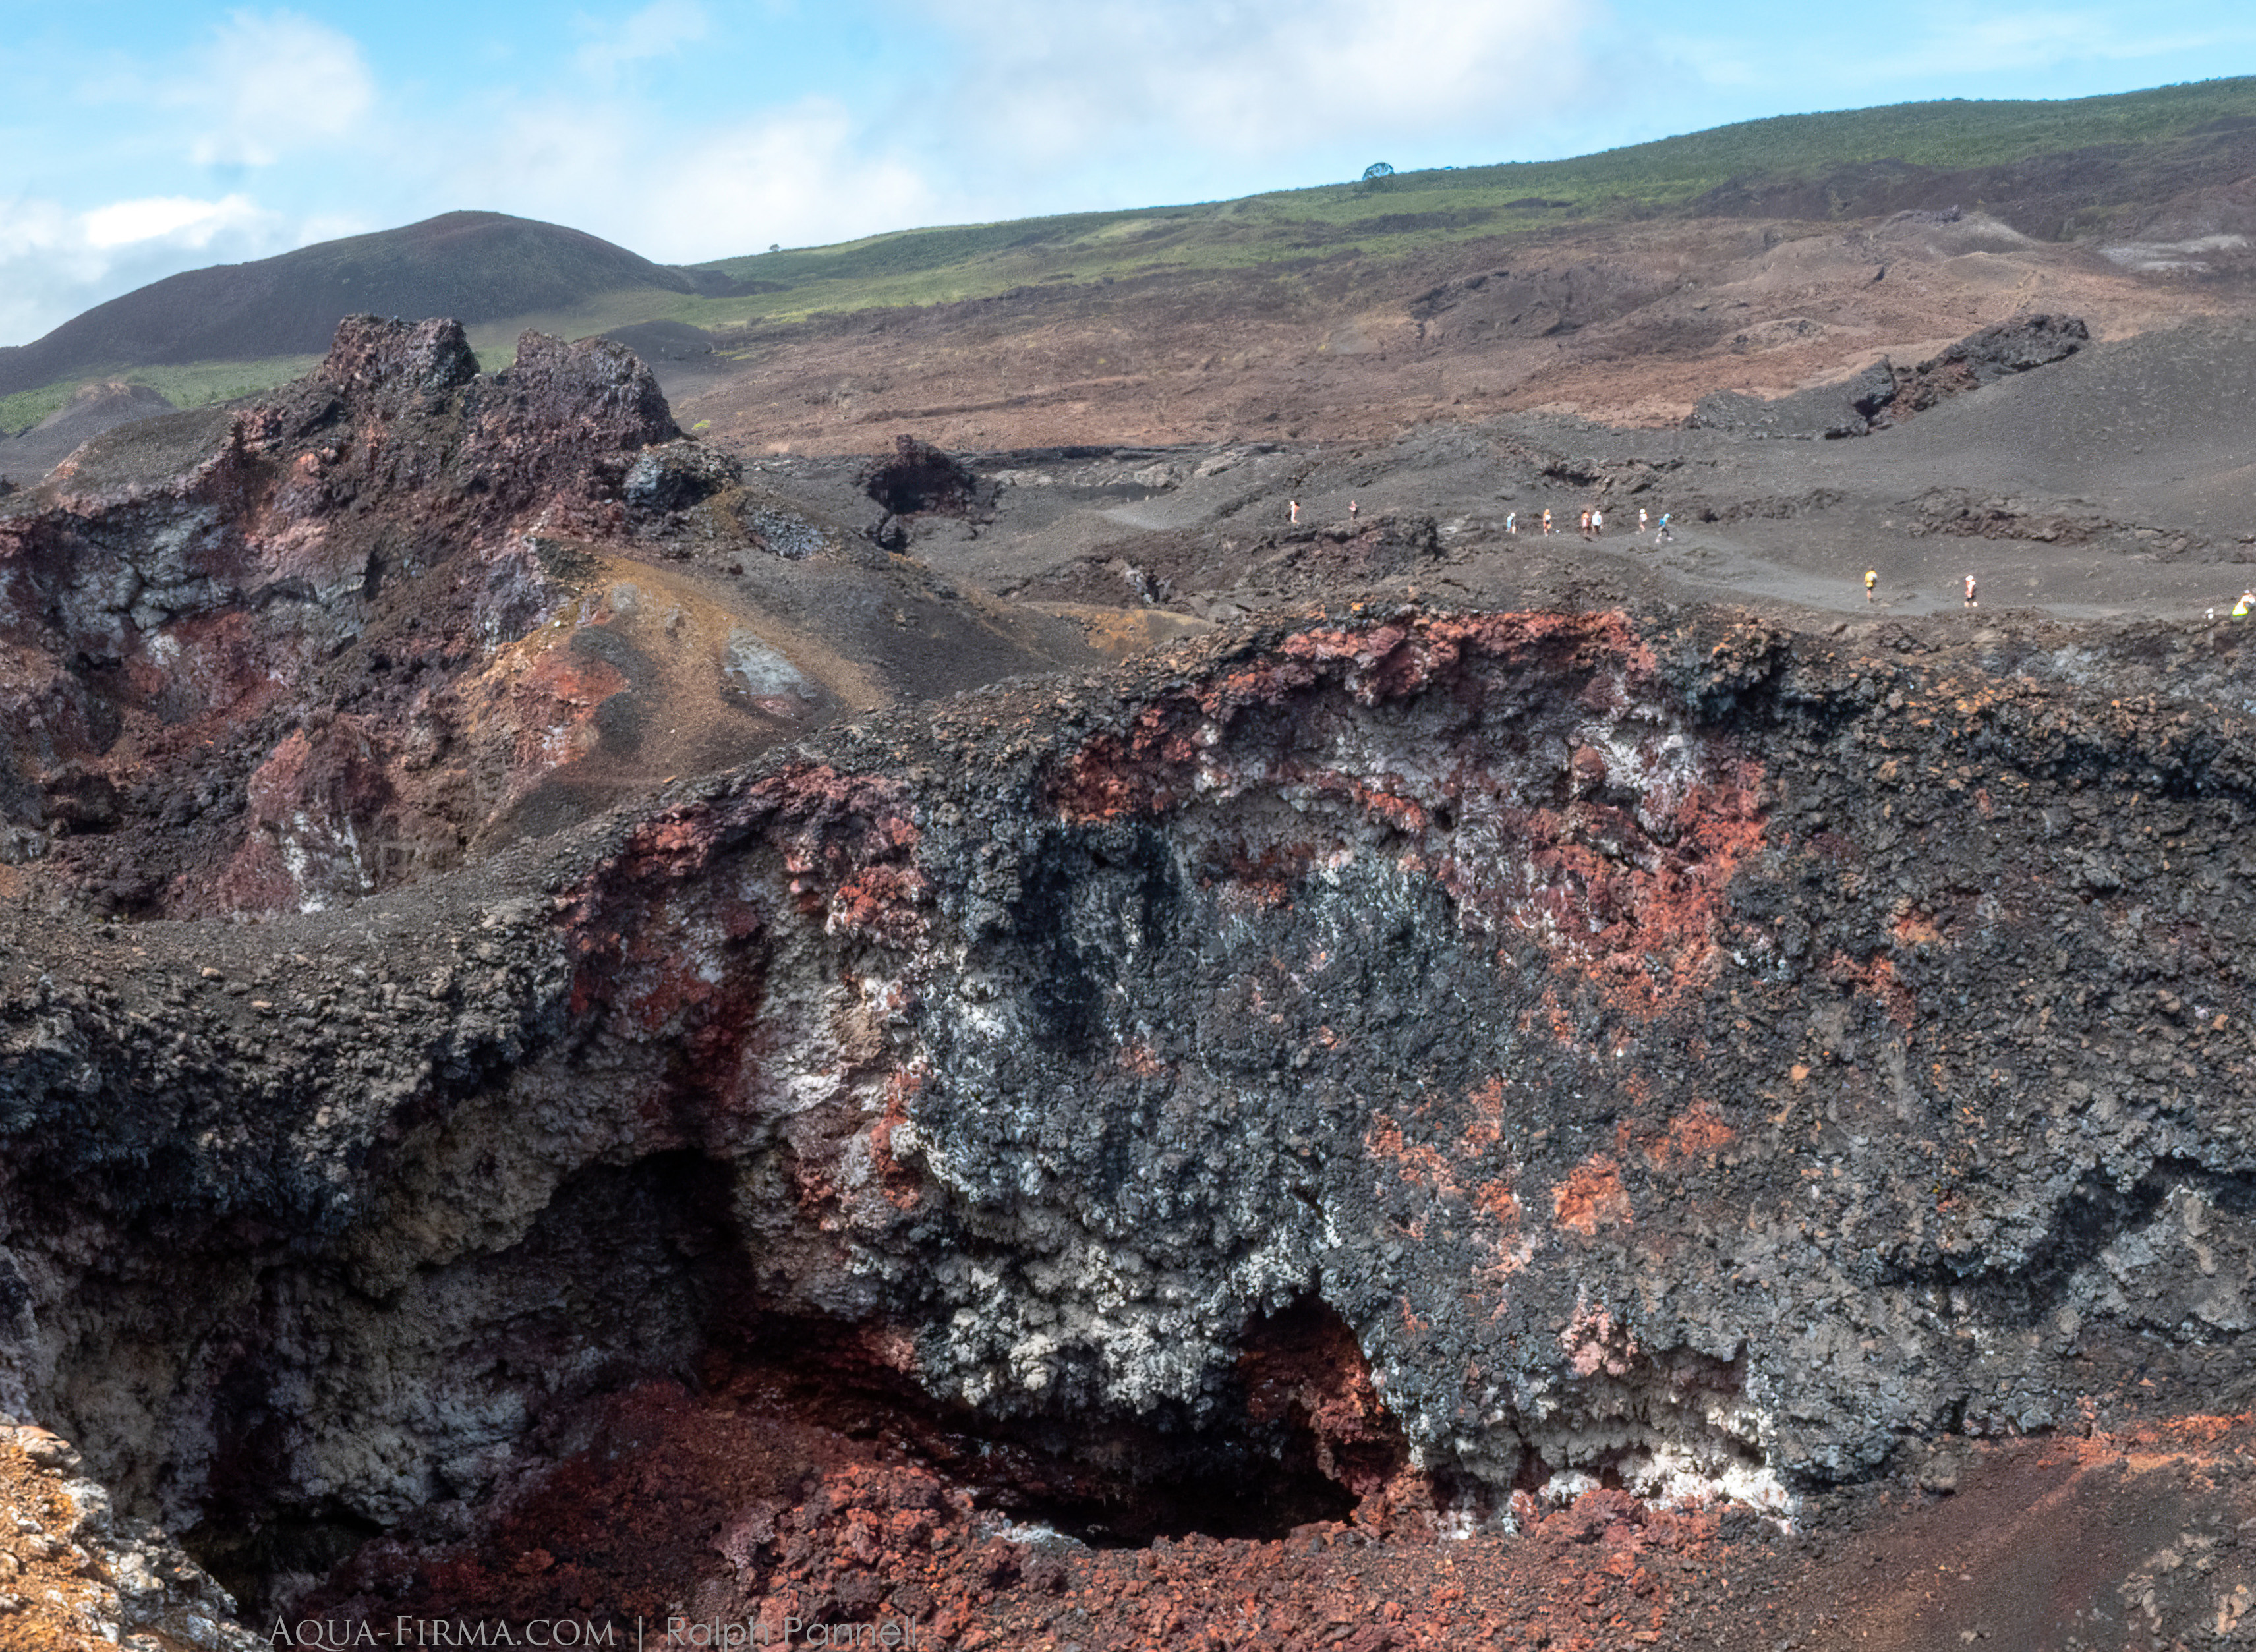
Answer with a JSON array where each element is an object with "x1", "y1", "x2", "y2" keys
[{"x1": 178, "y1": 11, "x2": 377, "y2": 167}]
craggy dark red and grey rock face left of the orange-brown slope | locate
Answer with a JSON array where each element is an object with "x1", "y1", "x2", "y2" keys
[{"x1": 0, "y1": 316, "x2": 679, "y2": 916}]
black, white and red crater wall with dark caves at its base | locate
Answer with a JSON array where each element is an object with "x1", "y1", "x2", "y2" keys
[{"x1": 0, "y1": 605, "x2": 2256, "y2": 1636}]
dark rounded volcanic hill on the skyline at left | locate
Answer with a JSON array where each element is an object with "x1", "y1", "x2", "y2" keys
[{"x1": 0, "y1": 212, "x2": 729, "y2": 395}]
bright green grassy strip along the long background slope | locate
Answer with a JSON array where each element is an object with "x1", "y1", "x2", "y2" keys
[{"x1": 17, "y1": 76, "x2": 2256, "y2": 431}]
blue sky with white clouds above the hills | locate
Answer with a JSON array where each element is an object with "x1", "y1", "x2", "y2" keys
[{"x1": 0, "y1": 0, "x2": 2256, "y2": 343}]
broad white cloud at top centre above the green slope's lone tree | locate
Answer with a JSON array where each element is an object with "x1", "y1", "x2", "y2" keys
[{"x1": 905, "y1": 0, "x2": 1595, "y2": 165}]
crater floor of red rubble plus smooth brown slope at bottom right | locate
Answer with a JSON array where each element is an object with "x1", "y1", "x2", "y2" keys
[{"x1": 304, "y1": 1390, "x2": 2256, "y2": 1652}]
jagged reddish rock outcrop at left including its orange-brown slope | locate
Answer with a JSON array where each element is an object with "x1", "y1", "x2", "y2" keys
[{"x1": 0, "y1": 316, "x2": 1078, "y2": 916}]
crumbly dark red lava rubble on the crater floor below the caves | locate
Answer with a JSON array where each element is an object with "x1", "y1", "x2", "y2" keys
[{"x1": 293, "y1": 1363, "x2": 1721, "y2": 1652}]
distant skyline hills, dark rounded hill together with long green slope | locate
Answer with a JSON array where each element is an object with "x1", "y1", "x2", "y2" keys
[{"x1": 0, "y1": 76, "x2": 2256, "y2": 431}]
